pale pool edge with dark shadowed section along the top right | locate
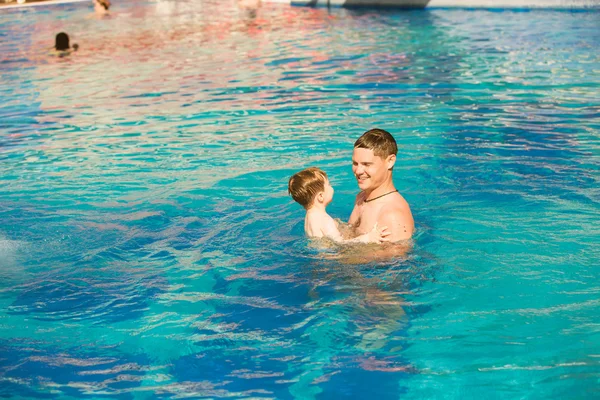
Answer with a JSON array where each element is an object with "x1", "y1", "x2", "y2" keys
[{"x1": 266, "y1": 0, "x2": 600, "y2": 8}]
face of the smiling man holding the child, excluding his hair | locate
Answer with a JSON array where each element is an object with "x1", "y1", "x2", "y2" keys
[{"x1": 352, "y1": 148, "x2": 396, "y2": 190}]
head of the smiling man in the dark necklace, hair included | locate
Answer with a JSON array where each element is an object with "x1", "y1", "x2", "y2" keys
[{"x1": 352, "y1": 129, "x2": 398, "y2": 191}]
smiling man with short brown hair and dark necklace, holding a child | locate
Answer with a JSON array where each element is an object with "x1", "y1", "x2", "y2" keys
[{"x1": 348, "y1": 129, "x2": 415, "y2": 242}]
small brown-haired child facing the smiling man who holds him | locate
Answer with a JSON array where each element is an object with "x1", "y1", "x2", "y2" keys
[{"x1": 288, "y1": 167, "x2": 389, "y2": 243}]
